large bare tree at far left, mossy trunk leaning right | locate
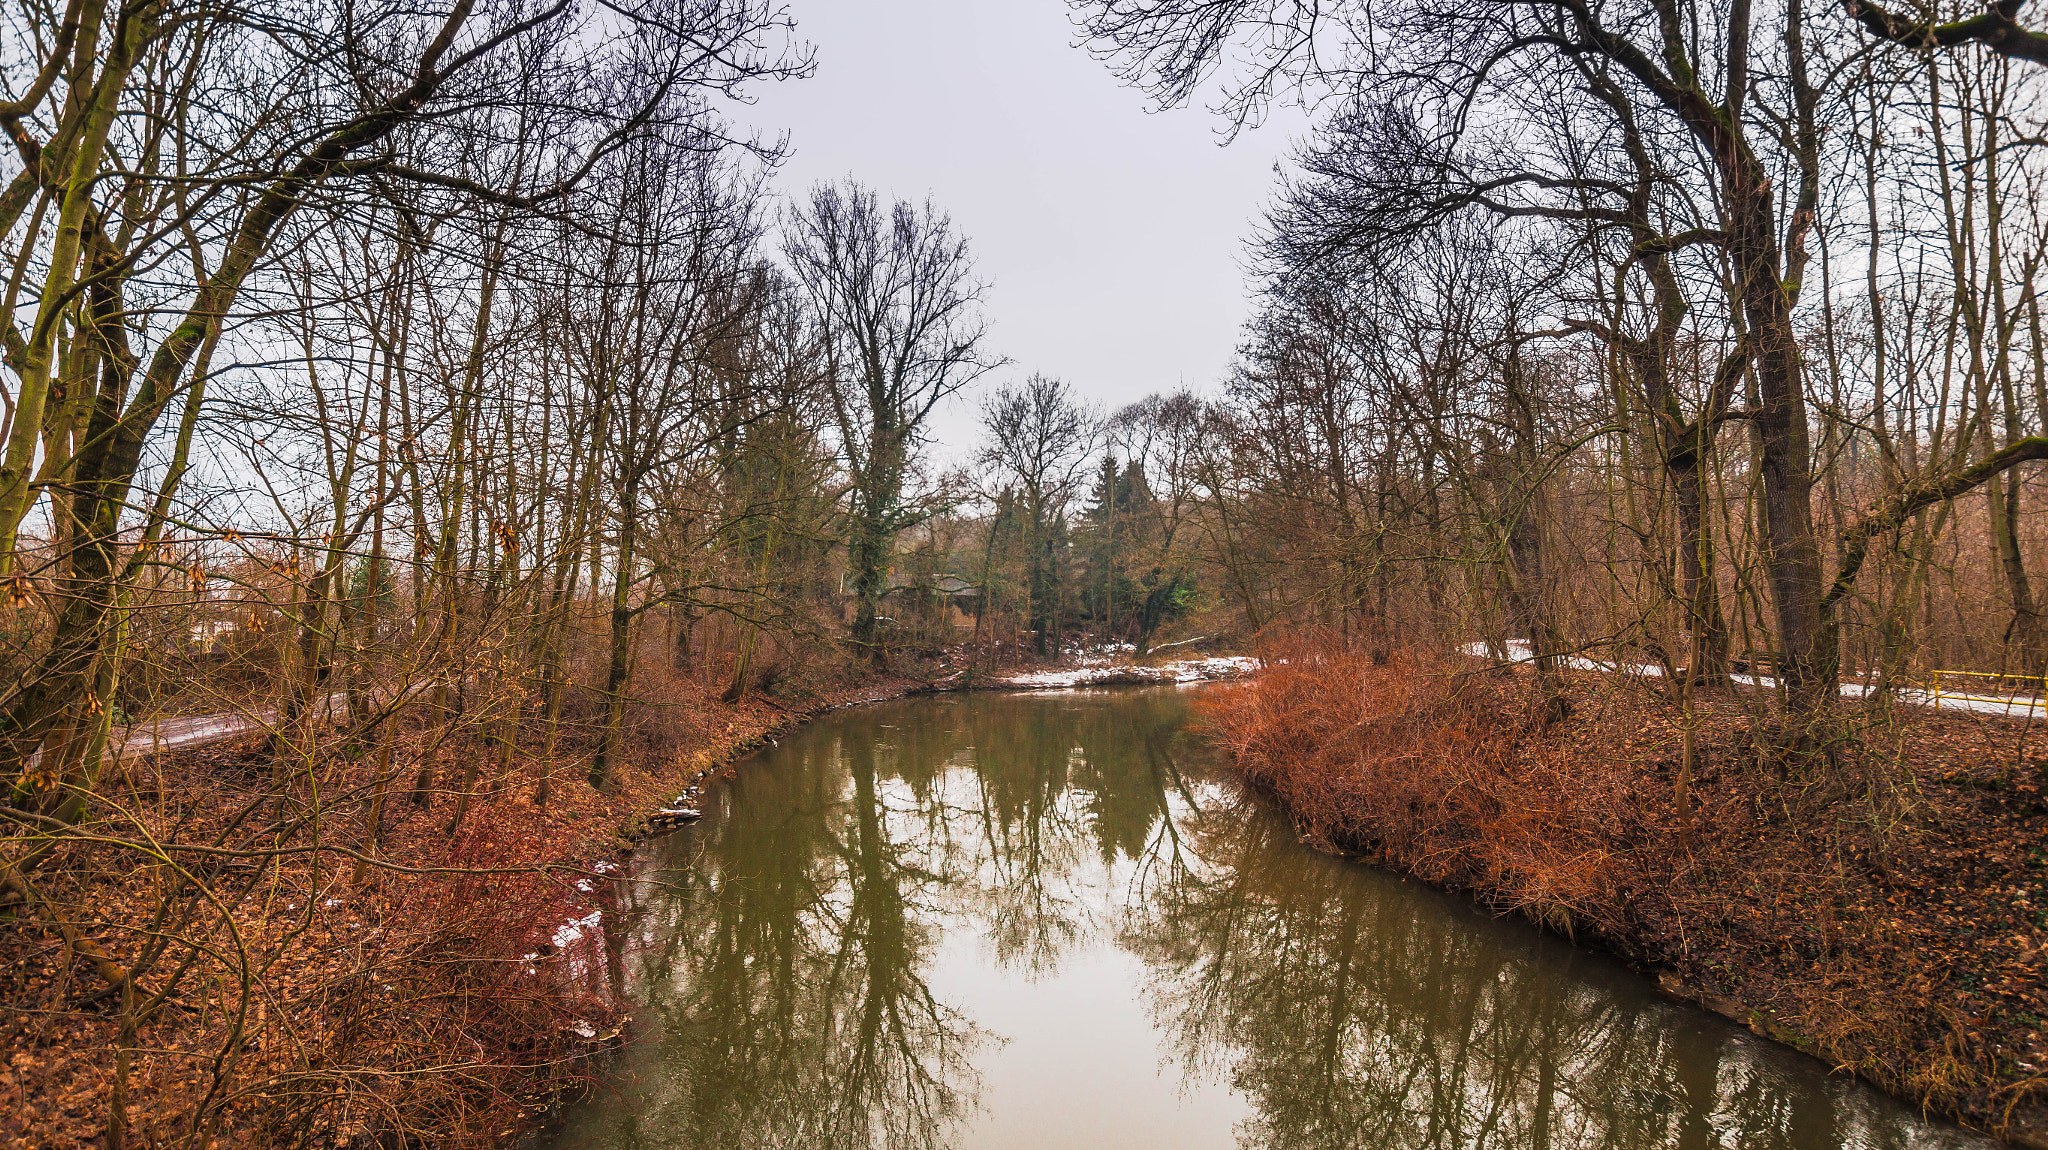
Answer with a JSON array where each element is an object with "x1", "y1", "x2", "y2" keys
[{"x1": 0, "y1": 0, "x2": 807, "y2": 806}]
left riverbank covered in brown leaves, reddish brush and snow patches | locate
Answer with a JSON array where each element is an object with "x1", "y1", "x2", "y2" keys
[{"x1": 0, "y1": 662, "x2": 920, "y2": 1150}]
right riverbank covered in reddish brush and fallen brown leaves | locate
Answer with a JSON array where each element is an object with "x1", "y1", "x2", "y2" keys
[{"x1": 1204, "y1": 653, "x2": 2048, "y2": 1146}]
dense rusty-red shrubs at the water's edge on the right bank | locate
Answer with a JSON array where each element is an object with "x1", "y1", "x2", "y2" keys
[{"x1": 1204, "y1": 638, "x2": 1638, "y2": 931}]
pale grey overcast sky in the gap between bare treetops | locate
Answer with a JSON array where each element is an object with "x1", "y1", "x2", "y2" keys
[{"x1": 737, "y1": 0, "x2": 1303, "y2": 458}]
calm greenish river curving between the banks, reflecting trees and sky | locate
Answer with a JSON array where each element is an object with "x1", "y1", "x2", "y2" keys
[{"x1": 545, "y1": 688, "x2": 1989, "y2": 1150}]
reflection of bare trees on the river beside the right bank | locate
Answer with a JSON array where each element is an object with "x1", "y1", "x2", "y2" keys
[{"x1": 1122, "y1": 781, "x2": 1974, "y2": 1150}]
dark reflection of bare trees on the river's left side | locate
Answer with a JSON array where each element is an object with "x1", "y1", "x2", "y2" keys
[{"x1": 559, "y1": 712, "x2": 981, "y2": 1150}]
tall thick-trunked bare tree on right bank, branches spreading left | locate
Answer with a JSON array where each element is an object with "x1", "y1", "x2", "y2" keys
[{"x1": 1081, "y1": 0, "x2": 2048, "y2": 714}]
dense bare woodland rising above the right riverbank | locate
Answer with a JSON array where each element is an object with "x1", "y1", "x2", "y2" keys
[{"x1": 1092, "y1": 2, "x2": 2048, "y2": 712}]
